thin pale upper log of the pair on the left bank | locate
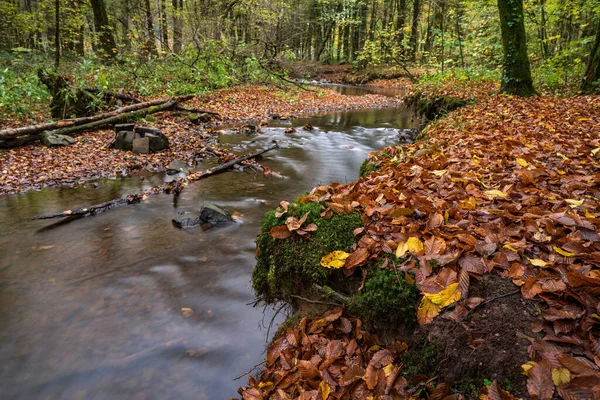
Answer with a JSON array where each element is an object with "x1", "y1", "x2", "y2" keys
[{"x1": 0, "y1": 95, "x2": 194, "y2": 139}]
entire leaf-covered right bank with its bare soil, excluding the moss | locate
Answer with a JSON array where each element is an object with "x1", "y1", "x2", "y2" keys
[{"x1": 240, "y1": 74, "x2": 600, "y2": 400}]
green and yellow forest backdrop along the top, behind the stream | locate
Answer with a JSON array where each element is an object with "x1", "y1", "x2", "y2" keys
[{"x1": 0, "y1": 0, "x2": 600, "y2": 118}]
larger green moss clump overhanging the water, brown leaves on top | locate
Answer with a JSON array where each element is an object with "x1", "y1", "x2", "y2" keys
[{"x1": 252, "y1": 202, "x2": 362, "y2": 302}]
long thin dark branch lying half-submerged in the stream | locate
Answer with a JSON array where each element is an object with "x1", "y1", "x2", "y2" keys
[{"x1": 32, "y1": 143, "x2": 279, "y2": 220}]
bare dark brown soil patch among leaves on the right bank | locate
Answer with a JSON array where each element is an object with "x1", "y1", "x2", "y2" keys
[{"x1": 409, "y1": 274, "x2": 539, "y2": 398}]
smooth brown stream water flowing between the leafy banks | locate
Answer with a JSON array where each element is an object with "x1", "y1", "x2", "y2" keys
[{"x1": 0, "y1": 88, "x2": 415, "y2": 399}]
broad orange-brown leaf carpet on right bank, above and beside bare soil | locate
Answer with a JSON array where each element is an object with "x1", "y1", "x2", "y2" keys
[{"x1": 268, "y1": 96, "x2": 600, "y2": 399}]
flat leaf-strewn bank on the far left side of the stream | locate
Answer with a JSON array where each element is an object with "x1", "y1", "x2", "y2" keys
[{"x1": 0, "y1": 85, "x2": 401, "y2": 194}]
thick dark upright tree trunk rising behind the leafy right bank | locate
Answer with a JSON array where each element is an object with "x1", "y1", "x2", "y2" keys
[{"x1": 498, "y1": 0, "x2": 536, "y2": 97}]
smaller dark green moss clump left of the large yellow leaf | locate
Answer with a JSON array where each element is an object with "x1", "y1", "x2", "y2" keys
[{"x1": 350, "y1": 255, "x2": 419, "y2": 328}]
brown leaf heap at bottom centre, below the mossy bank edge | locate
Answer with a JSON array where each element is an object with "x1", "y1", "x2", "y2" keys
[{"x1": 239, "y1": 308, "x2": 459, "y2": 400}]
